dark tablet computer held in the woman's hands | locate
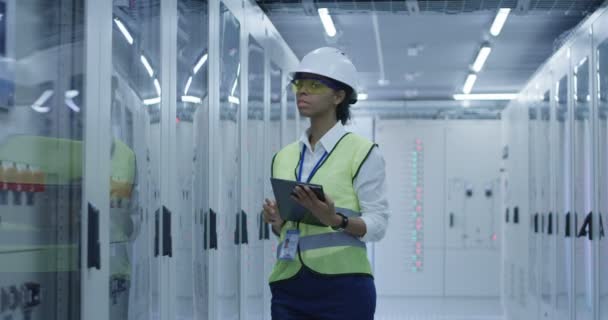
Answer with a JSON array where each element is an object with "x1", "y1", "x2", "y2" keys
[{"x1": 270, "y1": 178, "x2": 325, "y2": 225}]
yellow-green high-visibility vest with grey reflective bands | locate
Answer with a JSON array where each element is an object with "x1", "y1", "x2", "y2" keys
[{"x1": 270, "y1": 133, "x2": 376, "y2": 283}]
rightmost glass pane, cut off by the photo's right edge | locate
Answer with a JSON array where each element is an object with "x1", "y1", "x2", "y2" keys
[{"x1": 596, "y1": 40, "x2": 608, "y2": 320}]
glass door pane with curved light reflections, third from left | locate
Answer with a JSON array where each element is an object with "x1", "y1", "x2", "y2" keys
[{"x1": 171, "y1": 0, "x2": 209, "y2": 319}]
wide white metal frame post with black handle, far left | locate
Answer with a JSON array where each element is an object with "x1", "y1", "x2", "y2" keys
[{"x1": 81, "y1": 0, "x2": 112, "y2": 320}]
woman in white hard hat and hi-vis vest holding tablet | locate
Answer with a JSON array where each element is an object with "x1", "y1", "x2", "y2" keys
[{"x1": 264, "y1": 48, "x2": 388, "y2": 320}]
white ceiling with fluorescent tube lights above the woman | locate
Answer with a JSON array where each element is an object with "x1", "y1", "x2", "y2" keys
[{"x1": 258, "y1": 0, "x2": 601, "y2": 105}]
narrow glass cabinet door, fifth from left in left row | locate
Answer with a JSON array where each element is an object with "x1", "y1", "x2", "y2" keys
[{"x1": 240, "y1": 36, "x2": 271, "y2": 320}]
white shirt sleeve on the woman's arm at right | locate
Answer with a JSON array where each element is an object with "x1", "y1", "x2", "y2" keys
[{"x1": 354, "y1": 147, "x2": 390, "y2": 242}]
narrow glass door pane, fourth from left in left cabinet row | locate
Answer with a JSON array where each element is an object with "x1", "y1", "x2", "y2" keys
[{"x1": 216, "y1": 3, "x2": 241, "y2": 320}]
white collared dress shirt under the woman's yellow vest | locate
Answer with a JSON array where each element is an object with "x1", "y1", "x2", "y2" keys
[{"x1": 300, "y1": 122, "x2": 389, "y2": 242}]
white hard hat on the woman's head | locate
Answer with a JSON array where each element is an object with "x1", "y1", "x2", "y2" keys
[{"x1": 290, "y1": 47, "x2": 357, "y2": 103}]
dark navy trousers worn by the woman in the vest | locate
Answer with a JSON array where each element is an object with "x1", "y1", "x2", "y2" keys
[{"x1": 270, "y1": 267, "x2": 376, "y2": 320}]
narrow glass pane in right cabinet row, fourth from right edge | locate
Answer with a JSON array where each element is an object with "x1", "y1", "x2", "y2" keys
[{"x1": 536, "y1": 91, "x2": 555, "y2": 305}]
